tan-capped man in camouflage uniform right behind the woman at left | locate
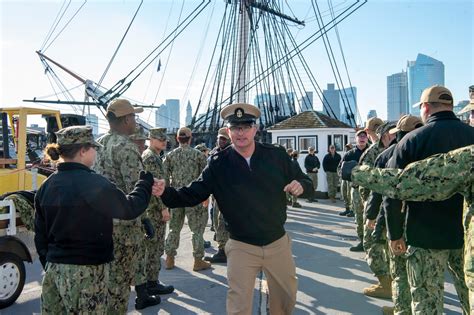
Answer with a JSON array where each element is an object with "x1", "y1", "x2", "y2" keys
[{"x1": 94, "y1": 99, "x2": 160, "y2": 314}]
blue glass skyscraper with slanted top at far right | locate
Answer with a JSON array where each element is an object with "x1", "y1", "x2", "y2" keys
[{"x1": 407, "y1": 54, "x2": 444, "y2": 116}]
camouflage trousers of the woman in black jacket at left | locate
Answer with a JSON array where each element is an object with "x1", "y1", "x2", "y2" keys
[{"x1": 41, "y1": 262, "x2": 109, "y2": 314}]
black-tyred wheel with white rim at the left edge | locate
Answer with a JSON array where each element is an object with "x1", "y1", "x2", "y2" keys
[{"x1": 0, "y1": 253, "x2": 25, "y2": 309}]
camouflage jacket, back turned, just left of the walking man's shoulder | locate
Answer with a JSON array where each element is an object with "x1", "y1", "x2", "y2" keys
[{"x1": 163, "y1": 144, "x2": 207, "y2": 188}]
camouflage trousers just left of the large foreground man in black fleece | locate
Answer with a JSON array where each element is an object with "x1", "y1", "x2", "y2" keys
[{"x1": 389, "y1": 252, "x2": 411, "y2": 315}]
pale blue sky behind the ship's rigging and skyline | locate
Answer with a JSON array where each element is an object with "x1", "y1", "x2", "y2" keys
[{"x1": 0, "y1": 0, "x2": 474, "y2": 128}]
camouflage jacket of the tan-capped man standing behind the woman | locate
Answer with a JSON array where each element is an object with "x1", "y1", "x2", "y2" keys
[{"x1": 93, "y1": 131, "x2": 143, "y2": 225}]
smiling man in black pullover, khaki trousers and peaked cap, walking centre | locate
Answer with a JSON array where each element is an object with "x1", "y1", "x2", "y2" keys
[{"x1": 154, "y1": 103, "x2": 313, "y2": 314}]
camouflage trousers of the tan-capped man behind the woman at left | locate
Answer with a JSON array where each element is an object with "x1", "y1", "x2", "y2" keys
[{"x1": 107, "y1": 225, "x2": 142, "y2": 314}]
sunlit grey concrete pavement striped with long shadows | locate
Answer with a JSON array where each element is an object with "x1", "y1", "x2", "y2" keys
[{"x1": 0, "y1": 200, "x2": 461, "y2": 314}]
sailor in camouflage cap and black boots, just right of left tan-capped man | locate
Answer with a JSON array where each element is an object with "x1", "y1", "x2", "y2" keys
[{"x1": 142, "y1": 128, "x2": 174, "y2": 295}]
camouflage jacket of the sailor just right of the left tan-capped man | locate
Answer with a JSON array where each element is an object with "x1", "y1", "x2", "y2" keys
[{"x1": 142, "y1": 148, "x2": 166, "y2": 221}]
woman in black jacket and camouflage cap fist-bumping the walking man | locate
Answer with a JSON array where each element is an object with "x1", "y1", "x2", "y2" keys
[{"x1": 34, "y1": 126, "x2": 154, "y2": 314}]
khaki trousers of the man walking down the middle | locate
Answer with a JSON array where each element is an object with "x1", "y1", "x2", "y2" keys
[{"x1": 225, "y1": 234, "x2": 298, "y2": 315}]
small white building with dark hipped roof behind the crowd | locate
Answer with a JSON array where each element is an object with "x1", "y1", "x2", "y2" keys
[{"x1": 268, "y1": 111, "x2": 355, "y2": 198}]
